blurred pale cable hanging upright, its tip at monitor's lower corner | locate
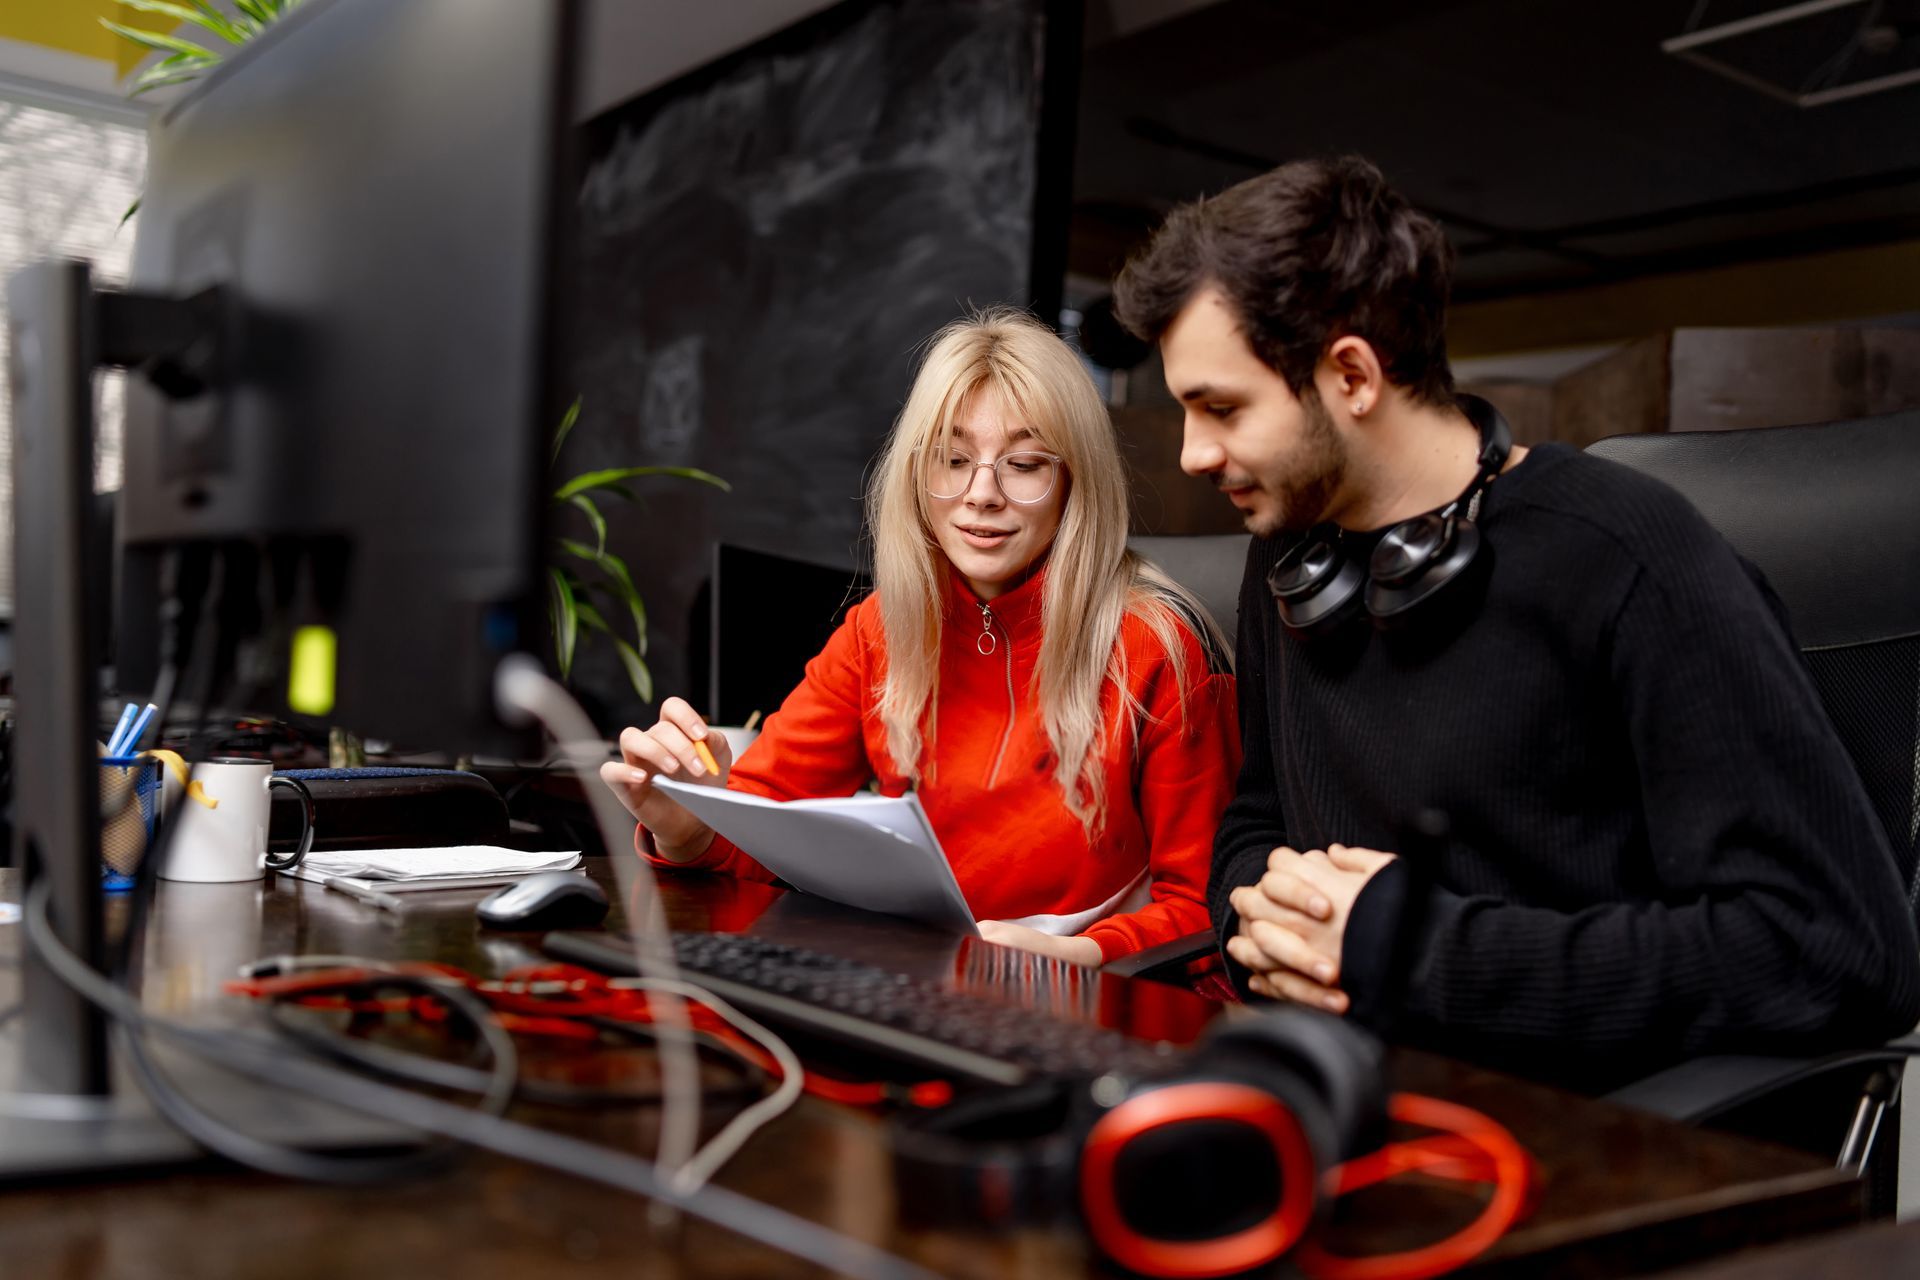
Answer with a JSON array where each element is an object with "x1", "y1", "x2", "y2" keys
[{"x1": 493, "y1": 654, "x2": 701, "y2": 1176}]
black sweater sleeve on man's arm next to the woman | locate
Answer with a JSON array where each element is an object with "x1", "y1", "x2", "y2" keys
[{"x1": 1206, "y1": 537, "x2": 1288, "y2": 998}]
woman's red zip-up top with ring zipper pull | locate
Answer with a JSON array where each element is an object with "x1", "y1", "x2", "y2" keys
[{"x1": 637, "y1": 570, "x2": 1240, "y2": 960}]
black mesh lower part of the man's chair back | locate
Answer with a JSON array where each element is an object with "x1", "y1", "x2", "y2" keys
[{"x1": 1807, "y1": 635, "x2": 1920, "y2": 917}]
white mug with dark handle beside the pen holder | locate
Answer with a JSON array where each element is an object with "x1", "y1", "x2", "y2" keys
[{"x1": 159, "y1": 756, "x2": 313, "y2": 883}]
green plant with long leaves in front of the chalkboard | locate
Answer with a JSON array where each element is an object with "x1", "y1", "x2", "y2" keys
[{"x1": 547, "y1": 399, "x2": 732, "y2": 702}]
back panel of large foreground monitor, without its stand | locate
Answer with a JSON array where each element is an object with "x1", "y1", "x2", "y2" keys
[{"x1": 119, "y1": 0, "x2": 568, "y2": 748}]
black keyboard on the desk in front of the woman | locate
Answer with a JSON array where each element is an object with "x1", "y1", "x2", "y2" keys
[{"x1": 543, "y1": 933, "x2": 1181, "y2": 1084}]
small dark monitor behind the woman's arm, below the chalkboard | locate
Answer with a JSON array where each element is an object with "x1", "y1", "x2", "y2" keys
[{"x1": 693, "y1": 543, "x2": 874, "y2": 725}]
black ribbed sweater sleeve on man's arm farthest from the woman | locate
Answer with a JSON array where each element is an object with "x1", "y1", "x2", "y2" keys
[{"x1": 1346, "y1": 532, "x2": 1920, "y2": 1065}]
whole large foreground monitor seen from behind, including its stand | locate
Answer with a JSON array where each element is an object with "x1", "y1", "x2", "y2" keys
[{"x1": 0, "y1": 0, "x2": 576, "y2": 1174}]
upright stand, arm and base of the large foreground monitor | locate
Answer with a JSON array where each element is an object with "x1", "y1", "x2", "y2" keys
[{"x1": 0, "y1": 261, "x2": 408, "y2": 1182}]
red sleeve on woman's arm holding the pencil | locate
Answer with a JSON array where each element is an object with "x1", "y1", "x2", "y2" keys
[{"x1": 634, "y1": 601, "x2": 879, "y2": 883}]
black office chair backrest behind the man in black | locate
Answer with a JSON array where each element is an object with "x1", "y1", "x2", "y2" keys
[{"x1": 1588, "y1": 413, "x2": 1920, "y2": 915}]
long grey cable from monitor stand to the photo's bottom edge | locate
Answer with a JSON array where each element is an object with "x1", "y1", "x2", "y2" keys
[{"x1": 25, "y1": 885, "x2": 935, "y2": 1280}]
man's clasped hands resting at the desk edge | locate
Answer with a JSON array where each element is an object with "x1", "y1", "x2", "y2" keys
[{"x1": 1227, "y1": 844, "x2": 1394, "y2": 1013}]
